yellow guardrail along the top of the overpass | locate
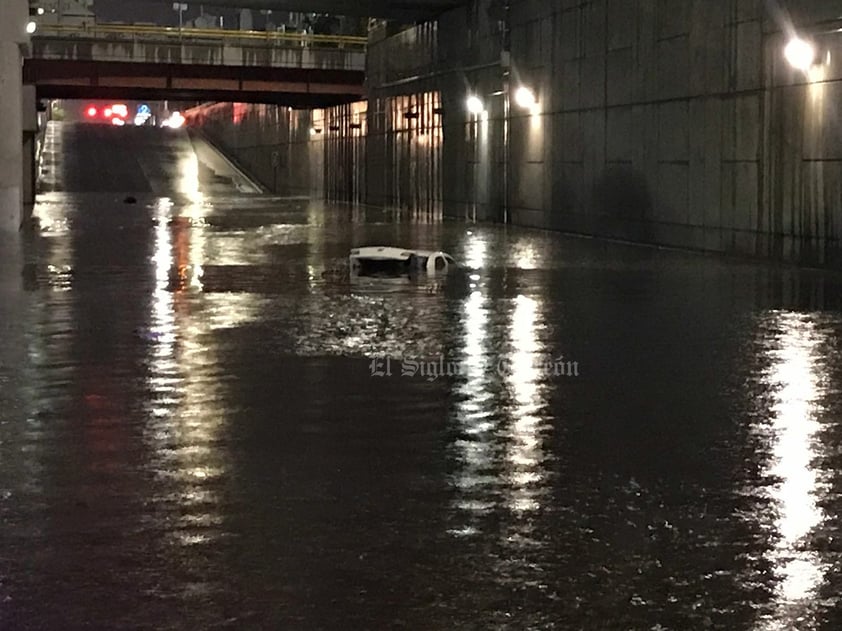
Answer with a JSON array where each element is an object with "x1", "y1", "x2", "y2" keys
[{"x1": 32, "y1": 24, "x2": 368, "y2": 50}]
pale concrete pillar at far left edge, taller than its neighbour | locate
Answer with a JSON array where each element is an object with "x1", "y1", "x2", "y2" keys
[{"x1": 0, "y1": 0, "x2": 29, "y2": 232}]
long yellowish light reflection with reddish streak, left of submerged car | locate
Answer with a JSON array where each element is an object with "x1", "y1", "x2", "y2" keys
[{"x1": 146, "y1": 191, "x2": 226, "y2": 546}]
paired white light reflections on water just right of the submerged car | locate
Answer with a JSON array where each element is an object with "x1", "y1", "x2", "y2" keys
[{"x1": 447, "y1": 233, "x2": 551, "y2": 618}]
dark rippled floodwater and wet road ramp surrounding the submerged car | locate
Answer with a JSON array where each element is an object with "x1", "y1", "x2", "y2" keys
[{"x1": 0, "y1": 125, "x2": 842, "y2": 630}]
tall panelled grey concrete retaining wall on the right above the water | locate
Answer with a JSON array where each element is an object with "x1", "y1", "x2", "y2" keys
[{"x1": 488, "y1": 0, "x2": 842, "y2": 264}]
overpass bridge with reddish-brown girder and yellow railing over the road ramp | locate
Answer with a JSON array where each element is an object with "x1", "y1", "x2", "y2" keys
[{"x1": 23, "y1": 24, "x2": 366, "y2": 108}]
